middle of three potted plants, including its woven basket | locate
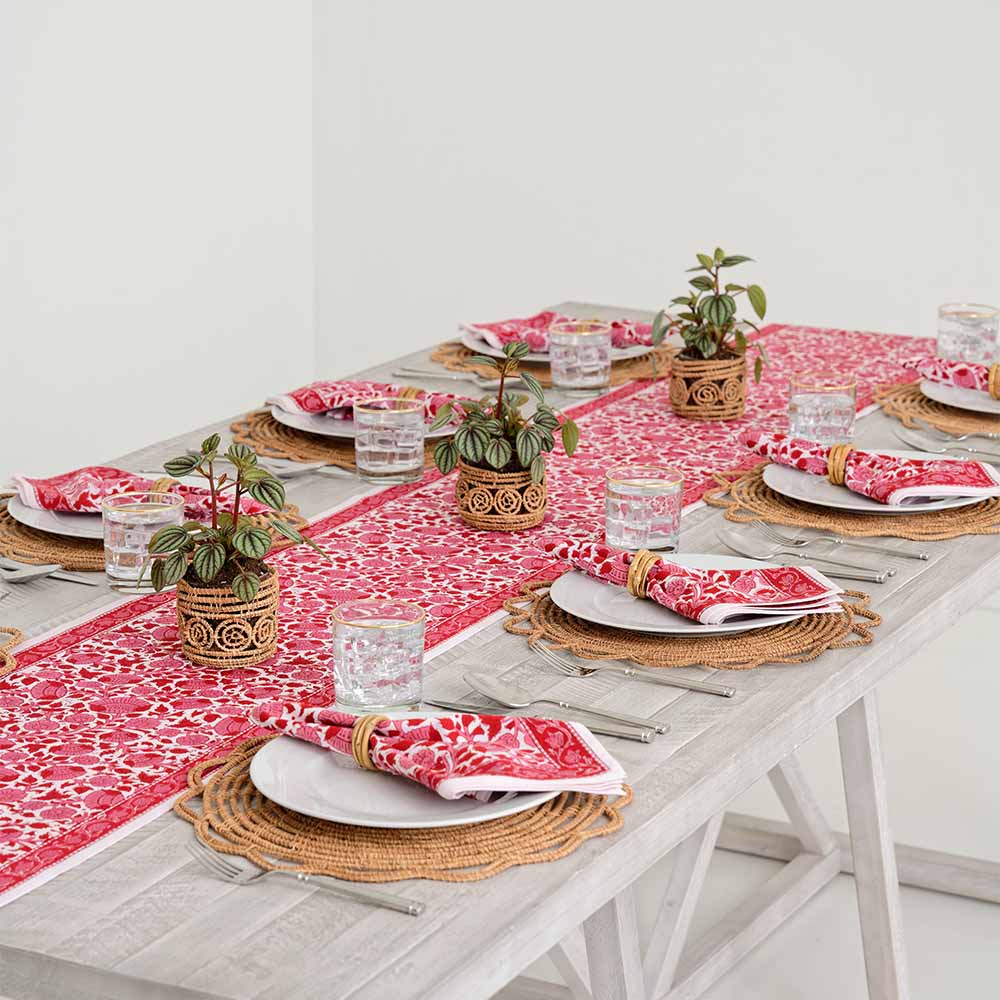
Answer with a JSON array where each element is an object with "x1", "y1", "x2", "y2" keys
[{"x1": 431, "y1": 342, "x2": 580, "y2": 531}]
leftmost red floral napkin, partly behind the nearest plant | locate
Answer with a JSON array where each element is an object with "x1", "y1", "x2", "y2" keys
[{"x1": 14, "y1": 465, "x2": 270, "y2": 521}]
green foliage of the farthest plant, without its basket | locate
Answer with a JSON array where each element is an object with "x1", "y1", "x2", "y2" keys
[{"x1": 652, "y1": 247, "x2": 768, "y2": 382}]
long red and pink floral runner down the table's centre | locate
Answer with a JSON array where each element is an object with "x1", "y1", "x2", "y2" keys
[{"x1": 0, "y1": 326, "x2": 930, "y2": 902}]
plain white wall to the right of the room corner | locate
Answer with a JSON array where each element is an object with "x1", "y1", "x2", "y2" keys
[{"x1": 314, "y1": 0, "x2": 1000, "y2": 374}]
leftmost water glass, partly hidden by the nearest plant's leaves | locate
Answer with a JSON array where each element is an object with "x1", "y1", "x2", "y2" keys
[{"x1": 101, "y1": 491, "x2": 184, "y2": 593}]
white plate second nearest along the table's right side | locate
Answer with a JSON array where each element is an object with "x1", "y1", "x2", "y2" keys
[{"x1": 549, "y1": 553, "x2": 806, "y2": 636}]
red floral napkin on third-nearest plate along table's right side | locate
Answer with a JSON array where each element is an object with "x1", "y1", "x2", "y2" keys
[{"x1": 740, "y1": 429, "x2": 1000, "y2": 506}]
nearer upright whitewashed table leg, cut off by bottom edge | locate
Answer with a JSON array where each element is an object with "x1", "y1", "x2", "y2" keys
[{"x1": 583, "y1": 886, "x2": 646, "y2": 1000}]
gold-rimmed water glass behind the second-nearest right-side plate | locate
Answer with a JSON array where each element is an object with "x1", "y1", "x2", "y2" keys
[{"x1": 604, "y1": 465, "x2": 684, "y2": 552}]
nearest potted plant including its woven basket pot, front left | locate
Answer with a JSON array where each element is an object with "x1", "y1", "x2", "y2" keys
[{"x1": 149, "y1": 434, "x2": 322, "y2": 668}]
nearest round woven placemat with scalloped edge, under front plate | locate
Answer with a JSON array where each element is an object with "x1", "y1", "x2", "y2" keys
[{"x1": 174, "y1": 737, "x2": 632, "y2": 882}]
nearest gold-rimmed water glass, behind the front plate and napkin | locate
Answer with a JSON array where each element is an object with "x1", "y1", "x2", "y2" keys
[{"x1": 333, "y1": 598, "x2": 425, "y2": 712}]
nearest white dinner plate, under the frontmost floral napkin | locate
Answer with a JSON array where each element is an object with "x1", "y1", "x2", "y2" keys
[{"x1": 250, "y1": 728, "x2": 559, "y2": 830}]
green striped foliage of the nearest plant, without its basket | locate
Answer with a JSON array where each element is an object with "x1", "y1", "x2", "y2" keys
[{"x1": 149, "y1": 434, "x2": 325, "y2": 601}]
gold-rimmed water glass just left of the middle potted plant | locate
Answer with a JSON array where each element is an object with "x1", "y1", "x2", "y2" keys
[{"x1": 354, "y1": 398, "x2": 425, "y2": 483}]
